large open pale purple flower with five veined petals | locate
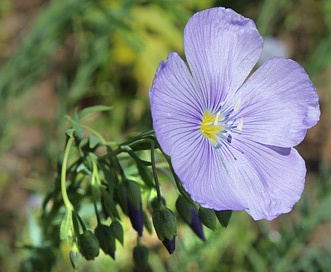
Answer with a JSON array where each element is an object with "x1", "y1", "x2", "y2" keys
[{"x1": 150, "y1": 8, "x2": 320, "y2": 220}]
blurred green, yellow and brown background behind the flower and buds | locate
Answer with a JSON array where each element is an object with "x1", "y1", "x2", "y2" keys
[{"x1": 0, "y1": 0, "x2": 331, "y2": 272}]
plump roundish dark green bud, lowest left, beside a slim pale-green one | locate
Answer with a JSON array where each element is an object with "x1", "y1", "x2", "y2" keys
[{"x1": 78, "y1": 230, "x2": 100, "y2": 260}]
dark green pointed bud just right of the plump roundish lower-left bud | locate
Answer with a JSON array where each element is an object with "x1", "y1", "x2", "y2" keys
[{"x1": 94, "y1": 224, "x2": 116, "y2": 260}]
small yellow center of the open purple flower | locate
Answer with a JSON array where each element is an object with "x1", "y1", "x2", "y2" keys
[{"x1": 200, "y1": 111, "x2": 224, "y2": 144}]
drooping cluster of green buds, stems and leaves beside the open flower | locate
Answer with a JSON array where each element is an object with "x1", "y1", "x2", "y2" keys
[{"x1": 54, "y1": 112, "x2": 231, "y2": 271}]
